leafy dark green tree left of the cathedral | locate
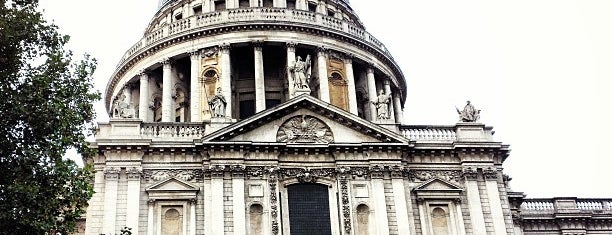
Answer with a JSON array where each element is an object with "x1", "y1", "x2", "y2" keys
[{"x1": 0, "y1": 0, "x2": 100, "y2": 234}]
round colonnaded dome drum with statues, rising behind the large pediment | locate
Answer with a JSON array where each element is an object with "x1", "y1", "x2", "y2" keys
[{"x1": 106, "y1": 0, "x2": 406, "y2": 124}]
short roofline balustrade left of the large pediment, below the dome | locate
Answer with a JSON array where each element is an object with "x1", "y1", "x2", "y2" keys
[{"x1": 140, "y1": 122, "x2": 205, "y2": 139}]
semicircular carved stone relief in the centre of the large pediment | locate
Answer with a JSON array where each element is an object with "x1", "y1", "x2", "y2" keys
[{"x1": 276, "y1": 115, "x2": 334, "y2": 143}]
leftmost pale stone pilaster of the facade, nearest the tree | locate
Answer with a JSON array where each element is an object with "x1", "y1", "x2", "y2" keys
[{"x1": 101, "y1": 167, "x2": 119, "y2": 234}]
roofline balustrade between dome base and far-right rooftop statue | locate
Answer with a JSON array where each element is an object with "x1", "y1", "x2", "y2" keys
[{"x1": 400, "y1": 126, "x2": 457, "y2": 141}]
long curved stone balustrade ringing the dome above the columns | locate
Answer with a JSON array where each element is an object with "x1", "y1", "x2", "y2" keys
[{"x1": 119, "y1": 8, "x2": 393, "y2": 64}]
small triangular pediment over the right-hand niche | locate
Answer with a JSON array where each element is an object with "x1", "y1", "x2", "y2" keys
[{"x1": 413, "y1": 178, "x2": 463, "y2": 199}]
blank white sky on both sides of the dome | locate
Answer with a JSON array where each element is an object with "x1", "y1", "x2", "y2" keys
[{"x1": 40, "y1": 0, "x2": 612, "y2": 197}]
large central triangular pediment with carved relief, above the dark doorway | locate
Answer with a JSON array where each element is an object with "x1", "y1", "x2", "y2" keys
[{"x1": 203, "y1": 95, "x2": 409, "y2": 144}]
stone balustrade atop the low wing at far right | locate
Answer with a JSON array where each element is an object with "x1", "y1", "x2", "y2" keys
[{"x1": 521, "y1": 198, "x2": 612, "y2": 214}]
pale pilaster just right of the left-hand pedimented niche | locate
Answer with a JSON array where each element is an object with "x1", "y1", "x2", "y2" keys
[{"x1": 210, "y1": 171, "x2": 225, "y2": 235}]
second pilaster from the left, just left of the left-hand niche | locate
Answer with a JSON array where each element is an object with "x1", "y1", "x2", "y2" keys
[{"x1": 125, "y1": 167, "x2": 142, "y2": 235}]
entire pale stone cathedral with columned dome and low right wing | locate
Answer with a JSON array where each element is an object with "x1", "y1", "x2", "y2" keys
[{"x1": 78, "y1": 0, "x2": 612, "y2": 235}]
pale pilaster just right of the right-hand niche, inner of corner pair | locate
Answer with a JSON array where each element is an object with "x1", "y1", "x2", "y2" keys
[{"x1": 465, "y1": 173, "x2": 487, "y2": 234}]
